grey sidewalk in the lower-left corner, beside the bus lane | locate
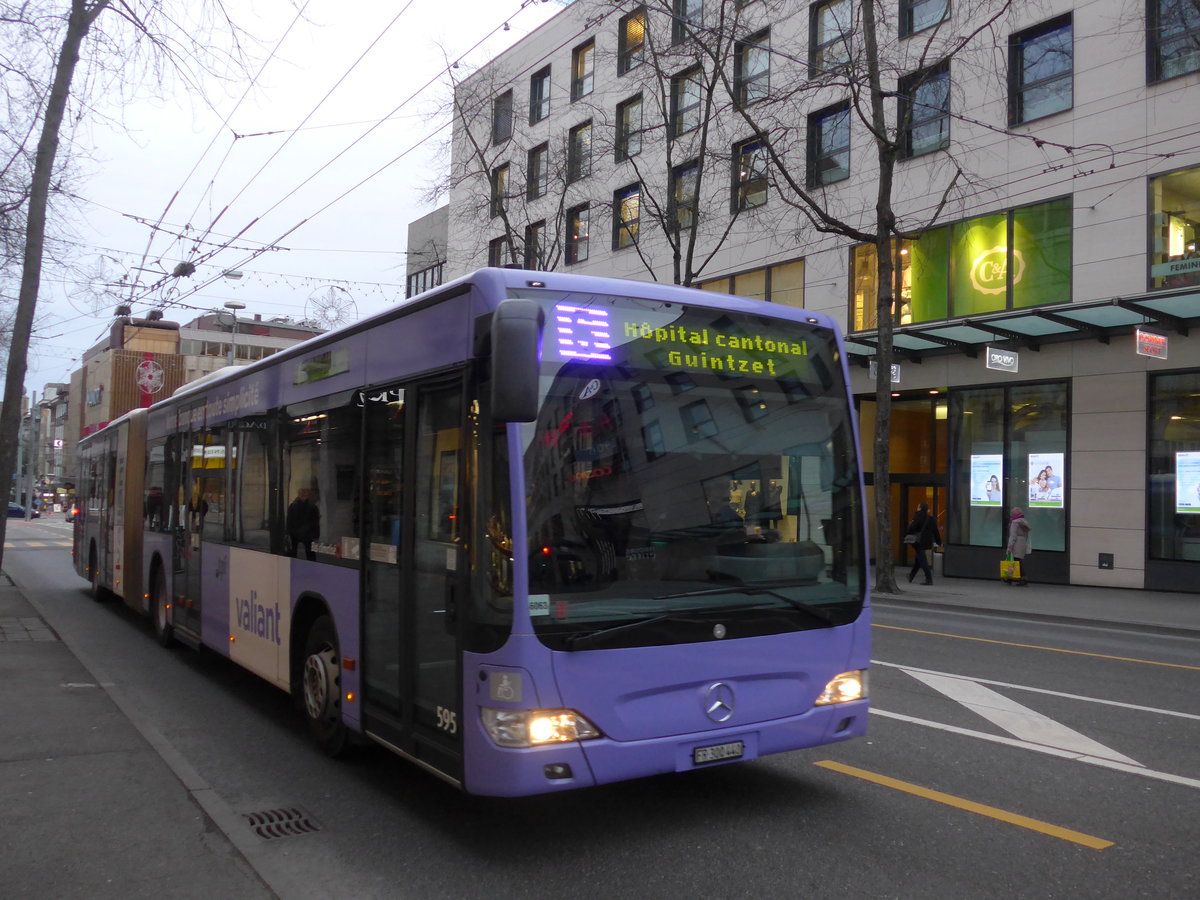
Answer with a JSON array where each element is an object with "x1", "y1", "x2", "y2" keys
[{"x1": 0, "y1": 572, "x2": 274, "y2": 900}]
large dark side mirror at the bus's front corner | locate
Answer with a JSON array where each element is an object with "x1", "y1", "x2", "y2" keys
[{"x1": 492, "y1": 299, "x2": 545, "y2": 425}]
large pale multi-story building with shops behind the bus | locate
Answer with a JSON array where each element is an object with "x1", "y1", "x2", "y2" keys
[{"x1": 445, "y1": 0, "x2": 1200, "y2": 590}]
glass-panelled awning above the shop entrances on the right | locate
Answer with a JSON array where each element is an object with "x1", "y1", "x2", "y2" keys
[{"x1": 846, "y1": 288, "x2": 1200, "y2": 366}]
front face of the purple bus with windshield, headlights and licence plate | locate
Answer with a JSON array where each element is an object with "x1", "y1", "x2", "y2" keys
[{"x1": 463, "y1": 286, "x2": 870, "y2": 794}]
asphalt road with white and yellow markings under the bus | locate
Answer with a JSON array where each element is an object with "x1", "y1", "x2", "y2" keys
[{"x1": 4, "y1": 520, "x2": 1200, "y2": 899}]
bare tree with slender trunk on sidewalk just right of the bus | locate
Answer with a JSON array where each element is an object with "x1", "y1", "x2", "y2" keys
[{"x1": 691, "y1": 0, "x2": 1012, "y2": 592}]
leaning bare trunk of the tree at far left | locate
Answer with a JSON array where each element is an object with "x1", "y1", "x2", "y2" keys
[{"x1": 0, "y1": 0, "x2": 110, "y2": 564}]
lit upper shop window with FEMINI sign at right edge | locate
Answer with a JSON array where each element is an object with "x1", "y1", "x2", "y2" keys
[{"x1": 1150, "y1": 168, "x2": 1200, "y2": 290}]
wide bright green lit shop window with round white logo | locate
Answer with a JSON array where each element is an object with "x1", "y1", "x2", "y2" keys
[{"x1": 851, "y1": 197, "x2": 1072, "y2": 331}]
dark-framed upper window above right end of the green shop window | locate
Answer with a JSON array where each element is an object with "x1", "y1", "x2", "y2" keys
[{"x1": 1008, "y1": 16, "x2": 1074, "y2": 125}]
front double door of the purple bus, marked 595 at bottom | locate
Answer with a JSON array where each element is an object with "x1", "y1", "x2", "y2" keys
[{"x1": 362, "y1": 382, "x2": 464, "y2": 779}]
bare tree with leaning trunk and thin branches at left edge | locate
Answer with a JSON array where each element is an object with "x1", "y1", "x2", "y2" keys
[{"x1": 0, "y1": 0, "x2": 253, "y2": 571}]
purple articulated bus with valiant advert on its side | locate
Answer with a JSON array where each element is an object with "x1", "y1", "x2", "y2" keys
[{"x1": 74, "y1": 269, "x2": 870, "y2": 796}]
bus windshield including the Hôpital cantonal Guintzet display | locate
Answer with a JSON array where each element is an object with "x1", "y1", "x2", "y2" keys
[{"x1": 522, "y1": 292, "x2": 865, "y2": 650}]
